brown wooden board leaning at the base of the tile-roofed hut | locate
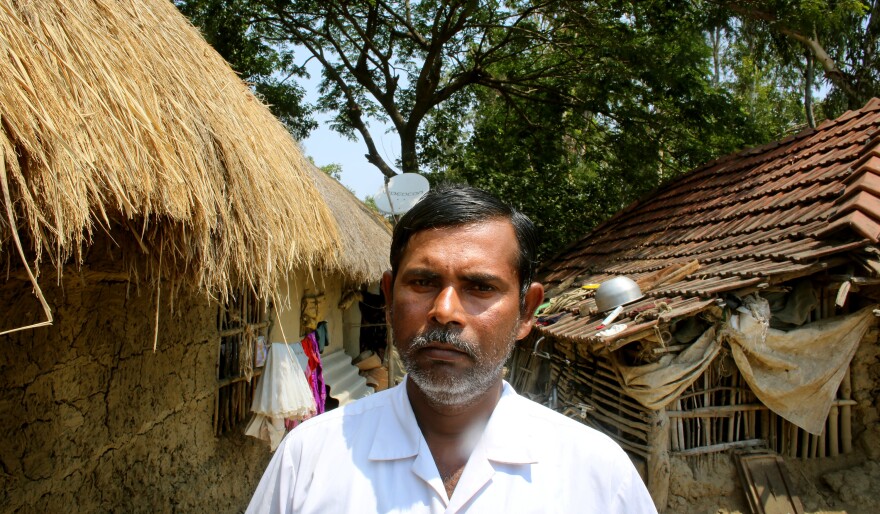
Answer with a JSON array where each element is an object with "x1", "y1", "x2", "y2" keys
[{"x1": 736, "y1": 453, "x2": 804, "y2": 514}]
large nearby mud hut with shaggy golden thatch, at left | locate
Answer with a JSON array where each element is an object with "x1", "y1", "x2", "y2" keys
[{"x1": 0, "y1": 0, "x2": 348, "y2": 512}]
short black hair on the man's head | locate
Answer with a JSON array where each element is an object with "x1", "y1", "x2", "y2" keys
[{"x1": 391, "y1": 184, "x2": 538, "y2": 306}]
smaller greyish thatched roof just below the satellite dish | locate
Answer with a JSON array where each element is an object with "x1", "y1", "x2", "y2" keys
[{"x1": 311, "y1": 166, "x2": 391, "y2": 283}]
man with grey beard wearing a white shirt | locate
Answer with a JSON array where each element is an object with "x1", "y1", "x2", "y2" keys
[{"x1": 248, "y1": 186, "x2": 655, "y2": 513}]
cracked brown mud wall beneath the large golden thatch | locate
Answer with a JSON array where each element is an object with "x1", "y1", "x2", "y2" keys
[{"x1": 0, "y1": 274, "x2": 270, "y2": 513}]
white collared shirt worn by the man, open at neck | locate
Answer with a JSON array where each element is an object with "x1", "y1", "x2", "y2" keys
[{"x1": 247, "y1": 374, "x2": 656, "y2": 514}]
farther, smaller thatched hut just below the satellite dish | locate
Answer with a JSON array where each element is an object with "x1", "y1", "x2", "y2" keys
[{"x1": 269, "y1": 166, "x2": 391, "y2": 405}]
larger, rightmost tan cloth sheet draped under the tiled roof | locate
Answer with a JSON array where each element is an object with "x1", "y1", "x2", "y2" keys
[{"x1": 723, "y1": 305, "x2": 877, "y2": 435}]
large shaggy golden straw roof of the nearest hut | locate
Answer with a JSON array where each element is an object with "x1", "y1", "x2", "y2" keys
[{"x1": 0, "y1": 0, "x2": 338, "y2": 295}]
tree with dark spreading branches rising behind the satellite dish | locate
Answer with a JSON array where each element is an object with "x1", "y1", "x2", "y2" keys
[{"x1": 180, "y1": 0, "x2": 644, "y2": 177}]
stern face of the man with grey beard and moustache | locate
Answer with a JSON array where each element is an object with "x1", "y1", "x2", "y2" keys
[{"x1": 382, "y1": 220, "x2": 543, "y2": 405}]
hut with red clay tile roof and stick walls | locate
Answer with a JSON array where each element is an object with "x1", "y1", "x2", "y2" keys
[{"x1": 514, "y1": 99, "x2": 880, "y2": 511}]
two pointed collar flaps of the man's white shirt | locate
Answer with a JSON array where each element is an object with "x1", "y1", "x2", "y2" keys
[{"x1": 369, "y1": 377, "x2": 541, "y2": 464}]
